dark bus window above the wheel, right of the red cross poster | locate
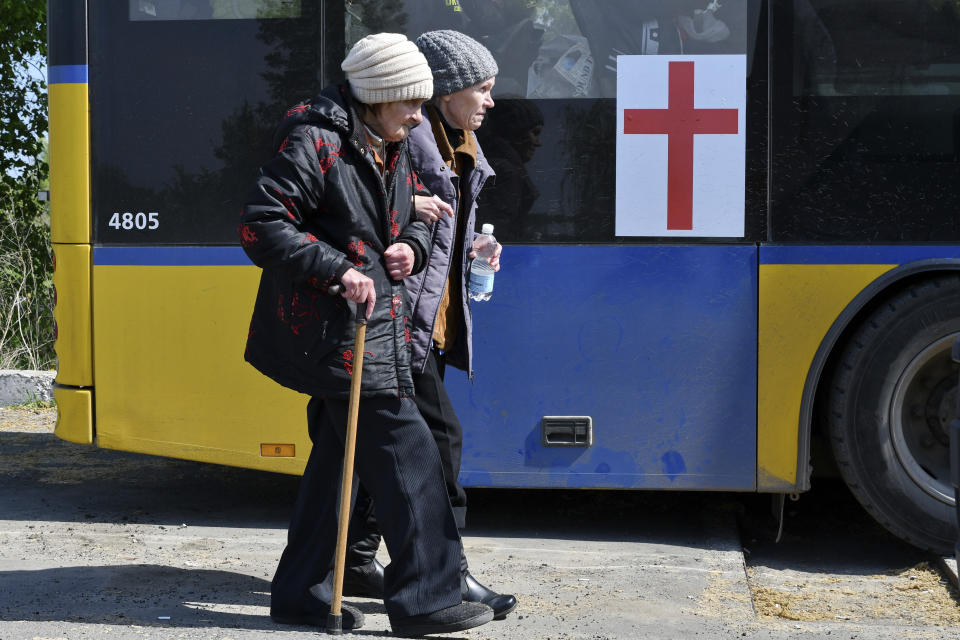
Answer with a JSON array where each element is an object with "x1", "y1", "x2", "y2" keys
[{"x1": 770, "y1": 0, "x2": 960, "y2": 243}]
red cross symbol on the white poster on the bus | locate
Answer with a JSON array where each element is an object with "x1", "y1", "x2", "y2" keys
[{"x1": 623, "y1": 62, "x2": 738, "y2": 230}]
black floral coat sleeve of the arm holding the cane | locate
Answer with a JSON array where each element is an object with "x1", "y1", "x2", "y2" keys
[{"x1": 239, "y1": 127, "x2": 352, "y2": 287}]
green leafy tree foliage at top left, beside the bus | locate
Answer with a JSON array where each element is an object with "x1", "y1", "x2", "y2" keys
[{"x1": 0, "y1": 0, "x2": 47, "y2": 183}]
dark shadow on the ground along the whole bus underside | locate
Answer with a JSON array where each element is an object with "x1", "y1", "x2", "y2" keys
[{"x1": 0, "y1": 432, "x2": 944, "y2": 574}]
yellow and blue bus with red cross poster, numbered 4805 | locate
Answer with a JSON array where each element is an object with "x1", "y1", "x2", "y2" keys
[{"x1": 49, "y1": 0, "x2": 960, "y2": 550}]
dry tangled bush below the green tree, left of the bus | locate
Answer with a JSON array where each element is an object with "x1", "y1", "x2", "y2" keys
[{"x1": 0, "y1": 170, "x2": 56, "y2": 369}]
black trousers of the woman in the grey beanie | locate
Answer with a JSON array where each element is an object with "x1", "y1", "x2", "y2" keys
[{"x1": 347, "y1": 349, "x2": 467, "y2": 571}]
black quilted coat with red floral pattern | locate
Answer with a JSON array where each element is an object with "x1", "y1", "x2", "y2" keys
[{"x1": 238, "y1": 86, "x2": 430, "y2": 397}]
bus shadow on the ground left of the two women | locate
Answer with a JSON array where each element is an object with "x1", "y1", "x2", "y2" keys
[{"x1": 0, "y1": 431, "x2": 299, "y2": 528}]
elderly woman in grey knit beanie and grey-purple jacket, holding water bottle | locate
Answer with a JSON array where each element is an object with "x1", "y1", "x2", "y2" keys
[{"x1": 345, "y1": 30, "x2": 517, "y2": 619}]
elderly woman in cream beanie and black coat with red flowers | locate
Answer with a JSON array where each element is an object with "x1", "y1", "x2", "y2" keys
[{"x1": 239, "y1": 34, "x2": 493, "y2": 636}]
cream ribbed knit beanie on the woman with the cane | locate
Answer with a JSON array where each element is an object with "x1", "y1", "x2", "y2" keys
[{"x1": 340, "y1": 33, "x2": 433, "y2": 104}]
